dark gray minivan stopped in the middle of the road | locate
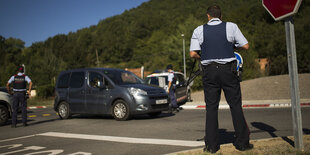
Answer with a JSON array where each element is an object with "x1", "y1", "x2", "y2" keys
[{"x1": 54, "y1": 68, "x2": 169, "y2": 120}]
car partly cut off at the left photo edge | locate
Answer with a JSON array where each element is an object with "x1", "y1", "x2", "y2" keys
[{"x1": 0, "y1": 87, "x2": 12, "y2": 126}]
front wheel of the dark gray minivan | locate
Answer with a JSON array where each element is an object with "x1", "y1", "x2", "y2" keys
[{"x1": 112, "y1": 100, "x2": 131, "y2": 121}]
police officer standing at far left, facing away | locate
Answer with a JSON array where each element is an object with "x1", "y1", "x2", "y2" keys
[{"x1": 6, "y1": 67, "x2": 32, "y2": 128}]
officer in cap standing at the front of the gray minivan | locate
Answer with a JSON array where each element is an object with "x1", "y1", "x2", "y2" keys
[{"x1": 167, "y1": 64, "x2": 179, "y2": 112}]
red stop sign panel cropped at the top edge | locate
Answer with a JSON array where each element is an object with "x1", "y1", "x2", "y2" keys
[{"x1": 262, "y1": 0, "x2": 302, "y2": 21}]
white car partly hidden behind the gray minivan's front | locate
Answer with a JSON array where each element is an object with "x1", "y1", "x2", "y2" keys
[{"x1": 145, "y1": 72, "x2": 191, "y2": 105}]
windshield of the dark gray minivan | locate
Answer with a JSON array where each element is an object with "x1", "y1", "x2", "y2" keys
[{"x1": 103, "y1": 70, "x2": 143, "y2": 85}]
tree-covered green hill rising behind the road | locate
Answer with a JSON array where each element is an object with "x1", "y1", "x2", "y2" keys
[{"x1": 23, "y1": 0, "x2": 310, "y2": 73}]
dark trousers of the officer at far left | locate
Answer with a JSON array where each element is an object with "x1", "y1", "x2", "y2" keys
[{"x1": 12, "y1": 92, "x2": 27, "y2": 125}]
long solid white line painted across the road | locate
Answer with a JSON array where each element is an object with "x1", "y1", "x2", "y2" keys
[{"x1": 37, "y1": 132, "x2": 204, "y2": 147}]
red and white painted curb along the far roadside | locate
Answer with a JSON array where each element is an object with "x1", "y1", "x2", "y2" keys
[{"x1": 181, "y1": 103, "x2": 310, "y2": 109}]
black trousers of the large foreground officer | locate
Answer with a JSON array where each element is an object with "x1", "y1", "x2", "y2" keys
[{"x1": 203, "y1": 63, "x2": 249, "y2": 149}]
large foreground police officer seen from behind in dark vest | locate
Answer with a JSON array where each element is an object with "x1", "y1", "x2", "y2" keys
[{"x1": 190, "y1": 5, "x2": 253, "y2": 153}]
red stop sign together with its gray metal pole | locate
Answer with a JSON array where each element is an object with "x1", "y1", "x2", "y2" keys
[{"x1": 262, "y1": 0, "x2": 304, "y2": 150}]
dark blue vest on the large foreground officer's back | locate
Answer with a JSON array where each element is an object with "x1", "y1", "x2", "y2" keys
[{"x1": 201, "y1": 22, "x2": 235, "y2": 60}]
